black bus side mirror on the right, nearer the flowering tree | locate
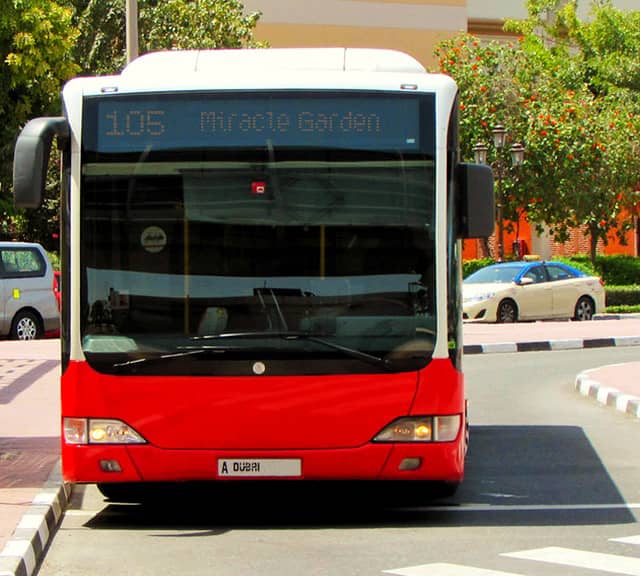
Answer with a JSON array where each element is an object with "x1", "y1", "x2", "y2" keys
[{"x1": 457, "y1": 164, "x2": 495, "y2": 238}]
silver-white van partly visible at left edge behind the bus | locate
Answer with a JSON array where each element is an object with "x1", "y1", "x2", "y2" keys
[{"x1": 0, "y1": 242, "x2": 60, "y2": 340}]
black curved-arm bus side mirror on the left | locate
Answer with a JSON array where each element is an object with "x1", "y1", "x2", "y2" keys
[{"x1": 13, "y1": 117, "x2": 69, "y2": 208}]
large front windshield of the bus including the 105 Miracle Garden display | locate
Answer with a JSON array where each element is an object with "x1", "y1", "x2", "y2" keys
[{"x1": 80, "y1": 93, "x2": 435, "y2": 375}]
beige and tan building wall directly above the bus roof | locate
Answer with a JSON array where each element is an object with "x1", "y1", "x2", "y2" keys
[{"x1": 244, "y1": 0, "x2": 467, "y2": 66}]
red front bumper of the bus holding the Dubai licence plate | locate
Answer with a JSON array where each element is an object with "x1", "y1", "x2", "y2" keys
[{"x1": 62, "y1": 434, "x2": 465, "y2": 483}]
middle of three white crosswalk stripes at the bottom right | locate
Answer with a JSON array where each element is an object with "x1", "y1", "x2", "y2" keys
[{"x1": 501, "y1": 546, "x2": 640, "y2": 576}]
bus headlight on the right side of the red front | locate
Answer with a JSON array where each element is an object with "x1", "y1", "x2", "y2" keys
[{"x1": 373, "y1": 414, "x2": 461, "y2": 442}]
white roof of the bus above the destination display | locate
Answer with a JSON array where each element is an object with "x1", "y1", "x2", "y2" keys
[{"x1": 63, "y1": 48, "x2": 457, "y2": 113}]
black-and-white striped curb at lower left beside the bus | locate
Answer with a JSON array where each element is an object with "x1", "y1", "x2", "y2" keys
[{"x1": 0, "y1": 462, "x2": 71, "y2": 576}]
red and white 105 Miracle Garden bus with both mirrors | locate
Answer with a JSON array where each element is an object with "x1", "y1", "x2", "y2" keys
[{"x1": 14, "y1": 48, "x2": 494, "y2": 495}]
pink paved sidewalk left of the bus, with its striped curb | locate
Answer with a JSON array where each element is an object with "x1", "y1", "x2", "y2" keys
[{"x1": 0, "y1": 340, "x2": 68, "y2": 576}]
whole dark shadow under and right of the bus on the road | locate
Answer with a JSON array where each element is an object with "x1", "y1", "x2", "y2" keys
[{"x1": 86, "y1": 426, "x2": 636, "y2": 535}]
